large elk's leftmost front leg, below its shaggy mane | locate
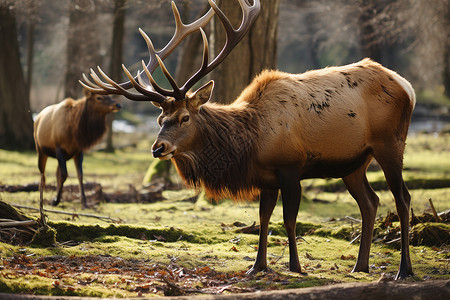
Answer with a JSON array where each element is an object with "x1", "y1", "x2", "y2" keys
[{"x1": 246, "y1": 190, "x2": 278, "y2": 275}]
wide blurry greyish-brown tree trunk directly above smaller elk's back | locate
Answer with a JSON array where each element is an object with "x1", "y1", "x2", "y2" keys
[{"x1": 64, "y1": 0, "x2": 100, "y2": 98}]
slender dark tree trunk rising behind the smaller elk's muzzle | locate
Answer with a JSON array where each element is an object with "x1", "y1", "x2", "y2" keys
[{"x1": 105, "y1": 0, "x2": 126, "y2": 152}]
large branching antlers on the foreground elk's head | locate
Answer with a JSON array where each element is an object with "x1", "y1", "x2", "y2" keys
[{"x1": 80, "y1": 0, "x2": 260, "y2": 103}]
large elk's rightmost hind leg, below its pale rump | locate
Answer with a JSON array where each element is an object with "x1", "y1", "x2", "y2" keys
[{"x1": 375, "y1": 148, "x2": 414, "y2": 279}]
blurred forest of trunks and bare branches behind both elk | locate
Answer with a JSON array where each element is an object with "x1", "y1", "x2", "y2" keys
[{"x1": 0, "y1": 0, "x2": 450, "y2": 149}]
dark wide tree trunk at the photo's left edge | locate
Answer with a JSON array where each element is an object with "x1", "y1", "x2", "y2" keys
[{"x1": 0, "y1": 1, "x2": 33, "y2": 149}]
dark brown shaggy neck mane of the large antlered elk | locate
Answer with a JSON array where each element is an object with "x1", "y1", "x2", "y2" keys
[{"x1": 173, "y1": 105, "x2": 259, "y2": 200}]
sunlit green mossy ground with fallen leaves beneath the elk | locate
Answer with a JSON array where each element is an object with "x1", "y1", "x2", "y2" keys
[{"x1": 0, "y1": 134, "x2": 450, "y2": 297}]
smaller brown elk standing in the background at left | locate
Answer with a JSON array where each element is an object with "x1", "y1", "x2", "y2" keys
[{"x1": 34, "y1": 89, "x2": 121, "y2": 207}]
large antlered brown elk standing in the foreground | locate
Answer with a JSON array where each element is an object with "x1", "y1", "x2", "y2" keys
[{"x1": 82, "y1": 0, "x2": 415, "y2": 278}]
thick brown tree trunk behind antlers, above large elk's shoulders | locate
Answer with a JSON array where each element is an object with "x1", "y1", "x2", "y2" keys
[{"x1": 212, "y1": 0, "x2": 280, "y2": 103}]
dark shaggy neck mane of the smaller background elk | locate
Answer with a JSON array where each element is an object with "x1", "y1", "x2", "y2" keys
[{"x1": 74, "y1": 100, "x2": 106, "y2": 151}]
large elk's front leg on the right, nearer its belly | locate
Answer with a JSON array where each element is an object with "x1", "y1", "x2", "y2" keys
[{"x1": 278, "y1": 168, "x2": 302, "y2": 273}]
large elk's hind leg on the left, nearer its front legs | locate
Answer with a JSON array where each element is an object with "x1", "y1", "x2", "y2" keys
[{"x1": 342, "y1": 159, "x2": 379, "y2": 272}]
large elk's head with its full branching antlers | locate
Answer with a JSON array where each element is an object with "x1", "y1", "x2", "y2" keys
[{"x1": 80, "y1": 0, "x2": 260, "y2": 159}]
